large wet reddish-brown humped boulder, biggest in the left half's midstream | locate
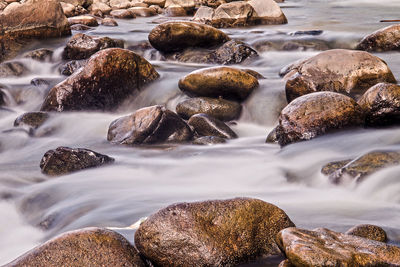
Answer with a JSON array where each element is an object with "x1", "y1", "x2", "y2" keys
[{"x1": 41, "y1": 48, "x2": 159, "y2": 111}]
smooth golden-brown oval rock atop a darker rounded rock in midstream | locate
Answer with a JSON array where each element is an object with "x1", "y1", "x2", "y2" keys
[{"x1": 179, "y1": 67, "x2": 258, "y2": 101}]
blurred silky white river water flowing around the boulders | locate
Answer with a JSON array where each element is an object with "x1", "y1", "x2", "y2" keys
[{"x1": 0, "y1": 0, "x2": 400, "y2": 263}]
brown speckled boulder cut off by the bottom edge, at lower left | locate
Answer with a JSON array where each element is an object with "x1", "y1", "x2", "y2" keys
[{"x1": 5, "y1": 227, "x2": 145, "y2": 267}]
